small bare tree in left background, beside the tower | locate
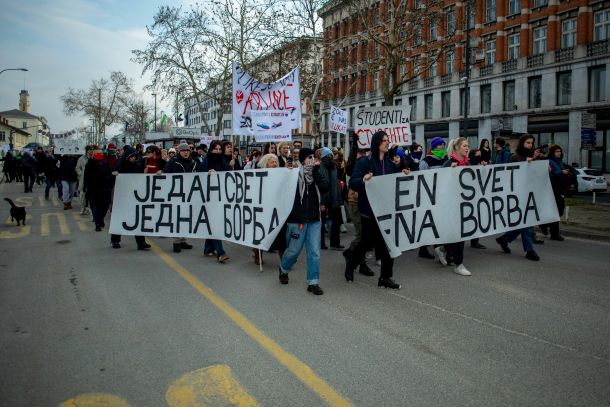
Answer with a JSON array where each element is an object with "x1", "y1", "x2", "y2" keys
[{"x1": 60, "y1": 71, "x2": 133, "y2": 144}]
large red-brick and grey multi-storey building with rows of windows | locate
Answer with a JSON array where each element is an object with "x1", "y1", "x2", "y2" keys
[{"x1": 319, "y1": 0, "x2": 610, "y2": 172}]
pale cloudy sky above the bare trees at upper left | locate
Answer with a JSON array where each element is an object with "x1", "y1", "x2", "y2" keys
[{"x1": 0, "y1": 0, "x2": 190, "y2": 136}]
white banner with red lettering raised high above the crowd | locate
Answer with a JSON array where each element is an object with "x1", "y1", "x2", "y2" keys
[{"x1": 232, "y1": 63, "x2": 301, "y2": 136}]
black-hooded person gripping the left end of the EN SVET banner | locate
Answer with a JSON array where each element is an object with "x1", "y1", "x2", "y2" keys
[{"x1": 344, "y1": 130, "x2": 410, "y2": 290}]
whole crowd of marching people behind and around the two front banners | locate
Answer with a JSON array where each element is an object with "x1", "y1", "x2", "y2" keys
[{"x1": 2, "y1": 131, "x2": 569, "y2": 295}]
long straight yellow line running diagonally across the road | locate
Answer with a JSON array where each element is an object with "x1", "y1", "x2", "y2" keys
[{"x1": 149, "y1": 241, "x2": 352, "y2": 406}]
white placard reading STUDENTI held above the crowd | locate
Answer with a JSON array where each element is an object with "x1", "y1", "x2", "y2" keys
[{"x1": 355, "y1": 105, "x2": 413, "y2": 148}]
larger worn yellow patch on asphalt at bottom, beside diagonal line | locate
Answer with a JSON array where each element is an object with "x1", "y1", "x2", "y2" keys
[{"x1": 165, "y1": 365, "x2": 259, "y2": 407}]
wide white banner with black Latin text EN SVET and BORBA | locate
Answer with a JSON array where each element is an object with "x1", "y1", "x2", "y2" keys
[{"x1": 365, "y1": 160, "x2": 559, "y2": 257}]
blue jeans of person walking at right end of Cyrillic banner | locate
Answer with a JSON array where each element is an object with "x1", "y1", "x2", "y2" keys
[{"x1": 280, "y1": 221, "x2": 322, "y2": 285}]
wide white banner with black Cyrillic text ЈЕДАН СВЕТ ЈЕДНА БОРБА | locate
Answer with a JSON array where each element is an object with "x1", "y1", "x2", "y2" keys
[{"x1": 110, "y1": 168, "x2": 299, "y2": 250}]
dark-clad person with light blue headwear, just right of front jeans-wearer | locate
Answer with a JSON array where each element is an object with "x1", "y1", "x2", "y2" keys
[{"x1": 318, "y1": 147, "x2": 345, "y2": 250}]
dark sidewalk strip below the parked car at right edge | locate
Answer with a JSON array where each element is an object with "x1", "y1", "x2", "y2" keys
[{"x1": 560, "y1": 198, "x2": 610, "y2": 242}]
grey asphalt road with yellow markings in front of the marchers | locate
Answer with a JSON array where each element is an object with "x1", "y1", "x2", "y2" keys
[{"x1": 0, "y1": 184, "x2": 610, "y2": 407}]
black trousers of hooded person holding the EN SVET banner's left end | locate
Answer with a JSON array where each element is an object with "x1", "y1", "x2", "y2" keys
[{"x1": 346, "y1": 216, "x2": 394, "y2": 278}]
